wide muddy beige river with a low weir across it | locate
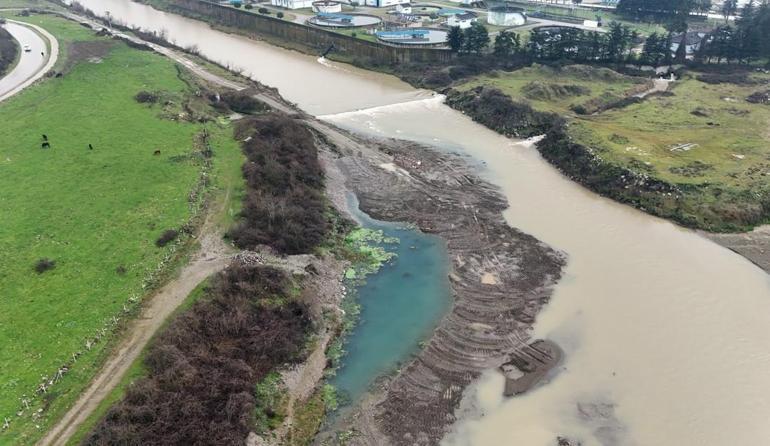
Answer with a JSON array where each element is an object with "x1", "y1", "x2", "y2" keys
[{"x1": 69, "y1": 0, "x2": 770, "y2": 446}]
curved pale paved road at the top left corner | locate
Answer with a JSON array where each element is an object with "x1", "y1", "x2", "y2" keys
[{"x1": 0, "y1": 20, "x2": 59, "y2": 101}]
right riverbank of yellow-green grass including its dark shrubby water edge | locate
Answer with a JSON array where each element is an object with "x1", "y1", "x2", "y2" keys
[{"x1": 449, "y1": 66, "x2": 770, "y2": 232}]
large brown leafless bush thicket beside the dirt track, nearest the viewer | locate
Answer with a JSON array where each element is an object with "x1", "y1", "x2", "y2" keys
[{"x1": 84, "y1": 265, "x2": 310, "y2": 446}]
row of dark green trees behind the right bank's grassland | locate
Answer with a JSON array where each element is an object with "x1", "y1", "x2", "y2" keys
[{"x1": 447, "y1": 0, "x2": 770, "y2": 66}]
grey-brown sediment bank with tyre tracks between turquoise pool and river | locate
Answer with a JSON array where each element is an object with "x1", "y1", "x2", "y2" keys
[{"x1": 315, "y1": 124, "x2": 565, "y2": 445}]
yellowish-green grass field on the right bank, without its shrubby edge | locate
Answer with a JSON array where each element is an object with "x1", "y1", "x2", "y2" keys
[{"x1": 573, "y1": 75, "x2": 770, "y2": 189}]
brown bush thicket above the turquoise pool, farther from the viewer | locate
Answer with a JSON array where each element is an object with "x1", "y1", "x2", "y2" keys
[{"x1": 229, "y1": 114, "x2": 328, "y2": 254}]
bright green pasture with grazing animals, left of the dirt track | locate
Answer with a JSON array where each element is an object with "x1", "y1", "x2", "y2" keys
[{"x1": 0, "y1": 13, "x2": 243, "y2": 444}]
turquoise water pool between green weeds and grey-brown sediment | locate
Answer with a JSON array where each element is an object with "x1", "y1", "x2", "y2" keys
[{"x1": 329, "y1": 198, "x2": 451, "y2": 402}]
